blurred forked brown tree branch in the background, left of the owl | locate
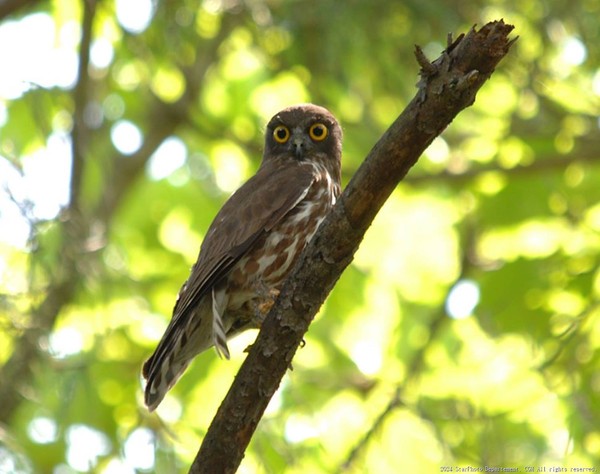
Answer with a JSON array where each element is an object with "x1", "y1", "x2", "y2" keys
[{"x1": 0, "y1": 7, "x2": 242, "y2": 424}]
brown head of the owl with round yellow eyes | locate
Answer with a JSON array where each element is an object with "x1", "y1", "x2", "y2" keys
[{"x1": 263, "y1": 104, "x2": 342, "y2": 173}]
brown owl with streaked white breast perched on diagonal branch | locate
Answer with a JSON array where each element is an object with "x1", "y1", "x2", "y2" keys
[{"x1": 143, "y1": 104, "x2": 342, "y2": 411}]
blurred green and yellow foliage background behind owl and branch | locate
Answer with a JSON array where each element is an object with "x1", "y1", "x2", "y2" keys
[{"x1": 0, "y1": 0, "x2": 600, "y2": 474}]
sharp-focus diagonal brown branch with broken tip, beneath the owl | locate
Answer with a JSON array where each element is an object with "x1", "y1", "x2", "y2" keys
[{"x1": 189, "y1": 20, "x2": 514, "y2": 474}]
